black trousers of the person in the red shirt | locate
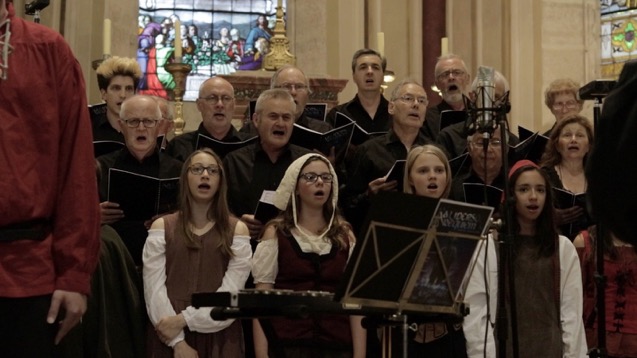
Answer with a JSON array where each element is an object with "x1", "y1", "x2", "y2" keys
[{"x1": 0, "y1": 295, "x2": 57, "y2": 358}]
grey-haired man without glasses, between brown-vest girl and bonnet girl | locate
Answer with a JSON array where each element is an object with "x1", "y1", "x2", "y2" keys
[{"x1": 223, "y1": 89, "x2": 310, "y2": 238}]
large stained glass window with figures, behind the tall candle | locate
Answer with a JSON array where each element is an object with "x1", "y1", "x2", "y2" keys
[{"x1": 137, "y1": 0, "x2": 286, "y2": 100}]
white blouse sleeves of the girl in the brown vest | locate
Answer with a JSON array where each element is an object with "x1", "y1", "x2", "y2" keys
[{"x1": 142, "y1": 229, "x2": 252, "y2": 347}]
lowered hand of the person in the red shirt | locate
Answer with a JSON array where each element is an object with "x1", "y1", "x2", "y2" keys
[{"x1": 46, "y1": 290, "x2": 86, "y2": 344}]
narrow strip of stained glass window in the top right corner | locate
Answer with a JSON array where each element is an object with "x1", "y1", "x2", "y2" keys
[{"x1": 600, "y1": 0, "x2": 637, "y2": 78}]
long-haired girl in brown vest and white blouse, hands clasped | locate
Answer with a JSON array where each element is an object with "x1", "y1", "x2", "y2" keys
[{"x1": 143, "y1": 149, "x2": 252, "y2": 358}]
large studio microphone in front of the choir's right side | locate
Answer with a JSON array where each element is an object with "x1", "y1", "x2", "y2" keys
[{"x1": 474, "y1": 66, "x2": 497, "y2": 135}]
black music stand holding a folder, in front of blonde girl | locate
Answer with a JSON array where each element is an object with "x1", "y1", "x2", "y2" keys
[{"x1": 335, "y1": 192, "x2": 493, "y2": 357}]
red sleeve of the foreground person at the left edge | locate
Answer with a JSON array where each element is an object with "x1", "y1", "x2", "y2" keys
[{"x1": 52, "y1": 37, "x2": 100, "y2": 294}]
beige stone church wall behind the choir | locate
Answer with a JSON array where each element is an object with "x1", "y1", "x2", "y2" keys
[{"x1": 14, "y1": 0, "x2": 600, "y2": 134}]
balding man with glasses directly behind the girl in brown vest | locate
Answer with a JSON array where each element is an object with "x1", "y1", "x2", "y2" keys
[{"x1": 166, "y1": 77, "x2": 248, "y2": 161}]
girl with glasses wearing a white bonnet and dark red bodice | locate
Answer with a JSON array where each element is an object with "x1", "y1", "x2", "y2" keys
[{"x1": 252, "y1": 154, "x2": 366, "y2": 357}]
